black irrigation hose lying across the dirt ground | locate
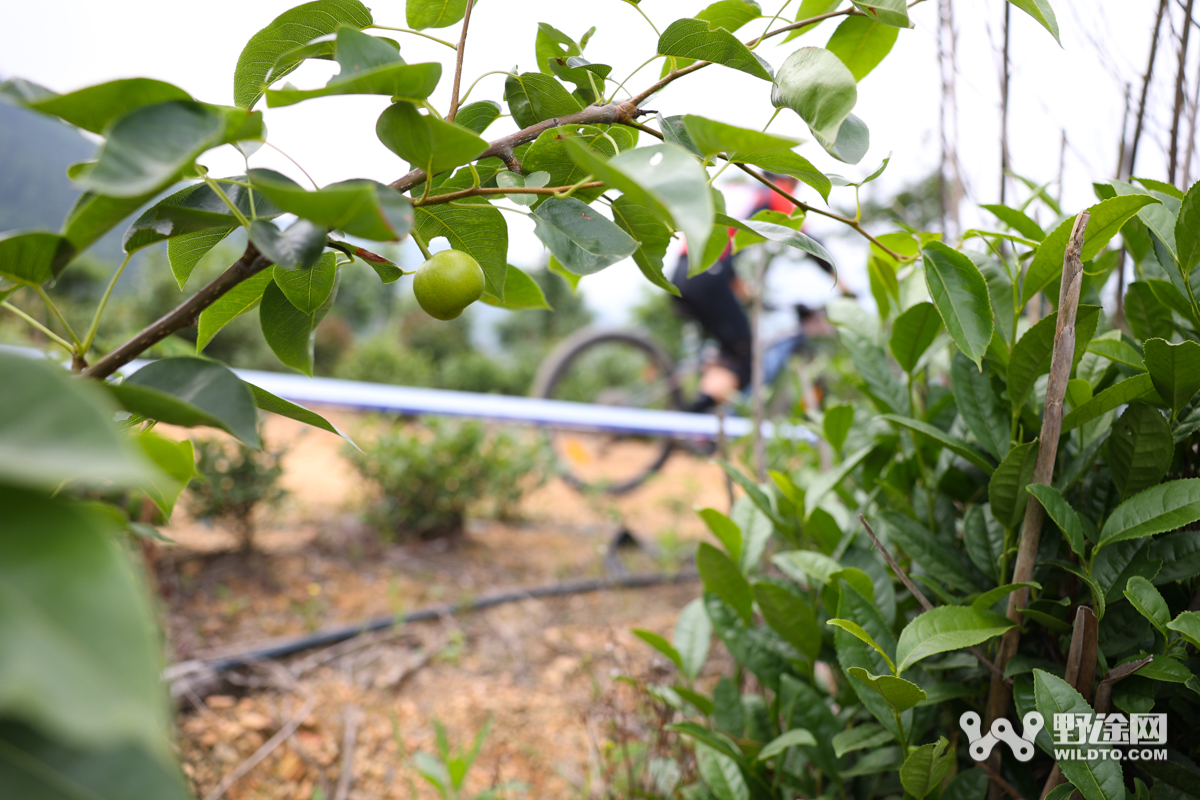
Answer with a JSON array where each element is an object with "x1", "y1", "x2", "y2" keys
[{"x1": 205, "y1": 571, "x2": 698, "y2": 673}]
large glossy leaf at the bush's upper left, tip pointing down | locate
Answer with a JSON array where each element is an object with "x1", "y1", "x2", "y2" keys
[{"x1": 922, "y1": 242, "x2": 994, "y2": 368}]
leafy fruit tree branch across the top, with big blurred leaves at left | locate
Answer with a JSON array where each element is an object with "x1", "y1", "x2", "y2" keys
[{"x1": 0, "y1": 0, "x2": 1070, "y2": 799}]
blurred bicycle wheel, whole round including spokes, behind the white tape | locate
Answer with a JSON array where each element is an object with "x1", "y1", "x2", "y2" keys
[{"x1": 532, "y1": 330, "x2": 682, "y2": 494}]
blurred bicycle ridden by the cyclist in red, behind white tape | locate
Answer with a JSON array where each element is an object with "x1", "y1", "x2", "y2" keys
[{"x1": 530, "y1": 306, "x2": 820, "y2": 494}]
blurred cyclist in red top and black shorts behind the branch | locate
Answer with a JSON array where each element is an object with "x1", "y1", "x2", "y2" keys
[{"x1": 671, "y1": 174, "x2": 850, "y2": 413}]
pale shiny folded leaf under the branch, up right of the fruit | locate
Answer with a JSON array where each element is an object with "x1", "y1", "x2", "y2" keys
[{"x1": 566, "y1": 139, "x2": 714, "y2": 261}]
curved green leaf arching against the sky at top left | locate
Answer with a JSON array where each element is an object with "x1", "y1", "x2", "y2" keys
[{"x1": 233, "y1": 0, "x2": 373, "y2": 108}]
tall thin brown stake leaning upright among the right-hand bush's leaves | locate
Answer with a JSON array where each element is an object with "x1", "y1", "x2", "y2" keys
[{"x1": 986, "y1": 211, "x2": 1090, "y2": 800}]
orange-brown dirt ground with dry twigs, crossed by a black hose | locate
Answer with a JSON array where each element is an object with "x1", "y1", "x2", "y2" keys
[{"x1": 157, "y1": 414, "x2": 728, "y2": 800}]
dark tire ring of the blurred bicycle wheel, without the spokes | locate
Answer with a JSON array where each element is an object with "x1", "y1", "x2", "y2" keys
[{"x1": 530, "y1": 329, "x2": 683, "y2": 494}]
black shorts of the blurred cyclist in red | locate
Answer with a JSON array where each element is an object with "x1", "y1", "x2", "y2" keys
[{"x1": 671, "y1": 253, "x2": 752, "y2": 389}]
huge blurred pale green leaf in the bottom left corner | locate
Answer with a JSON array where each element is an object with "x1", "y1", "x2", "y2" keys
[{"x1": 0, "y1": 489, "x2": 180, "y2": 767}]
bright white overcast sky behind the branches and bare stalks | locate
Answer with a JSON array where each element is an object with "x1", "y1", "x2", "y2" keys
[{"x1": 0, "y1": 0, "x2": 1180, "y2": 326}]
